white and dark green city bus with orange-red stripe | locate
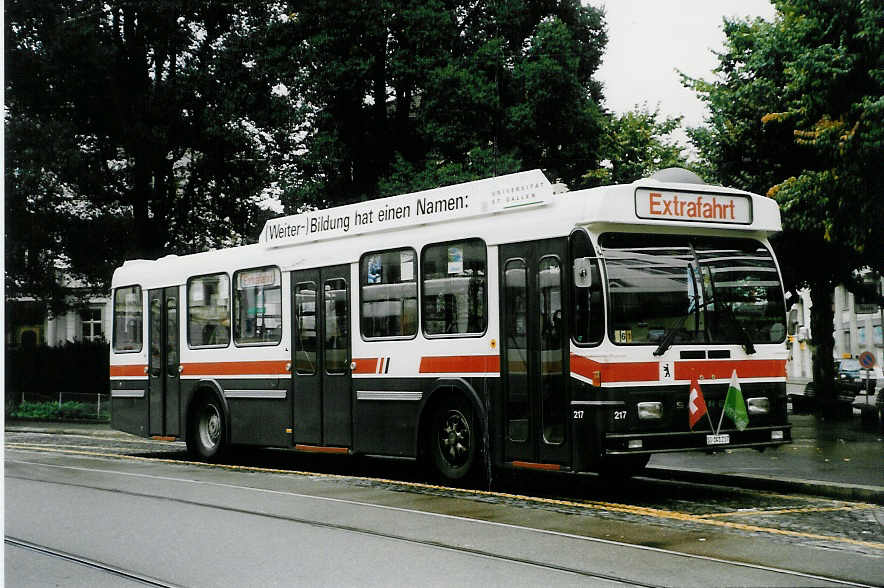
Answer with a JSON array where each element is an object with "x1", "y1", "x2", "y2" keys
[{"x1": 110, "y1": 170, "x2": 791, "y2": 480}]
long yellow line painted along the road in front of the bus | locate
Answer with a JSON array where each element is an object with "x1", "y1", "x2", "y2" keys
[{"x1": 6, "y1": 443, "x2": 884, "y2": 550}]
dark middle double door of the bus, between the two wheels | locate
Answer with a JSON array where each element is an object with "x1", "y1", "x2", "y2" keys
[{"x1": 292, "y1": 265, "x2": 353, "y2": 447}]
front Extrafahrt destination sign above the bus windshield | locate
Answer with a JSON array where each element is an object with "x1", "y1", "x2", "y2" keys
[{"x1": 635, "y1": 188, "x2": 752, "y2": 225}]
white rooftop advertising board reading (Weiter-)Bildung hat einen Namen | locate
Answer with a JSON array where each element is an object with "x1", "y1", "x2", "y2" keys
[{"x1": 259, "y1": 170, "x2": 552, "y2": 247}]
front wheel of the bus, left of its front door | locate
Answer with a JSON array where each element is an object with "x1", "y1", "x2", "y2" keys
[{"x1": 428, "y1": 396, "x2": 481, "y2": 481}]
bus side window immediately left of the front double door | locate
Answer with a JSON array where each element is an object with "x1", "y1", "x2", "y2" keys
[{"x1": 421, "y1": 239, "x2": 488, "y2": 336}]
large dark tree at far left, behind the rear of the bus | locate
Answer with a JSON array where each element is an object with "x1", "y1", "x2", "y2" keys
[{"x1": 6, "y1": 0, "x2": 284, "y2": 307}]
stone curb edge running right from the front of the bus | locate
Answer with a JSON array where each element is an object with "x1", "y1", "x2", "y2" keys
[{"x1": 641, "y1": 466, "x2": 884, "y2": 505}]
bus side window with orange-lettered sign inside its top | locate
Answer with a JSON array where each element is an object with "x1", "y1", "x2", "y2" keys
[{"x1": 233, "y1": 267, "x2": 282, "y2": 345}]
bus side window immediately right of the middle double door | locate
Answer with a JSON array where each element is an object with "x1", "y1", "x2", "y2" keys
[{"x1": 359, "y1": 249, "x2": 417, "y2": 339}]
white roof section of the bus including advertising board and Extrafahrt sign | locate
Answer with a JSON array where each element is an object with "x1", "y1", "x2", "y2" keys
[{"x1": 113, "y1": 170, "x2": 781, "y2": 288}]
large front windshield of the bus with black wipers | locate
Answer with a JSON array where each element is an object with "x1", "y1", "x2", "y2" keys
[{"x1": 599, "y1": 233, "x2": 786, "y2": 346}]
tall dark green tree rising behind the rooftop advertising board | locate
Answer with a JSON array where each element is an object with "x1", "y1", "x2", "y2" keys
[{"x1": 267, "y1": 0, "x2": 606, "y2": 209}]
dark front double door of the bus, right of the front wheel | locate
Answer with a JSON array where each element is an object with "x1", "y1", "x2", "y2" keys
[{"x1": 500, "y1": 239, "x2": 571, "y2": 465}]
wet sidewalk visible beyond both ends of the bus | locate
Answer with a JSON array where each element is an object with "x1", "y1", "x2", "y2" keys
[{"x1": 6, "y1": 414, "x2": 884, "y2": 504}]
